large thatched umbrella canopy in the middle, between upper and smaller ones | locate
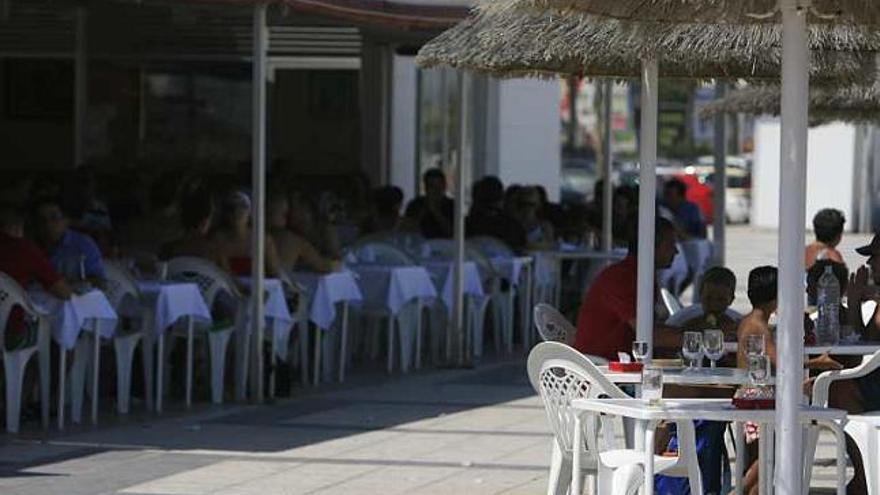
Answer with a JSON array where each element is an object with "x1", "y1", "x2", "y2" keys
[{"x1": 417, "y1": 0, "x2": 880, "y2": 82}]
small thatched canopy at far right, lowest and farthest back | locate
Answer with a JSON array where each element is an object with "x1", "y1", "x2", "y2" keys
[{"x1": 700, "y1": 84, "x2": 880, "y2": 125}]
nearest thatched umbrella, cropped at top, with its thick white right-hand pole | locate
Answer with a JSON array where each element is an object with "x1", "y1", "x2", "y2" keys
[{"x1": 482, "y1": 0, "x2": 880, "y2": 495}]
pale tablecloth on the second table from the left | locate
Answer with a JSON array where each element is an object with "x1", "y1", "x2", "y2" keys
[{"x1": 138, "y1": 280, "x2": 211, "y2": 336}]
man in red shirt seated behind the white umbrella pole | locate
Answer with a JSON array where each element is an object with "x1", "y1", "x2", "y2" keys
[{"x1": 574, "y1": 217, "x2": 680, "y2": 361}]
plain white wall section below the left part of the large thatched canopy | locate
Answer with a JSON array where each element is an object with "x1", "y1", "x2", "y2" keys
[{"x1": 497, "y1": 79, "x2": 561, "y2": 201}]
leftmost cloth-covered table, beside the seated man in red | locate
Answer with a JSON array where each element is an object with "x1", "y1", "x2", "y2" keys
[{"x1": 30, "y1": 290, "x2": 119, "y2": 428}]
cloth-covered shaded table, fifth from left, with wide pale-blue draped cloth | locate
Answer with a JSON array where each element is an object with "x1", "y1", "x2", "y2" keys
[{"x1": 349, "y1": 264, "x2": 437, "y2": 372}]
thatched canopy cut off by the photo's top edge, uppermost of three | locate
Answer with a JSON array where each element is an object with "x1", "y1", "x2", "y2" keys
[{"x1": 499, "y1": 0, "x2": 880, "y2": 24}]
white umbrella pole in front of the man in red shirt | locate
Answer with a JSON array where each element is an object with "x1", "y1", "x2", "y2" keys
[{"x1": 636, "y1": 58, "x2": 658, "y2": 356}]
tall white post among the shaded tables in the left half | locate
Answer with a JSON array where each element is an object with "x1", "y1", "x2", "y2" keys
[{"x1": 244, "y1": 4, "x2": 269, "y2": 402}]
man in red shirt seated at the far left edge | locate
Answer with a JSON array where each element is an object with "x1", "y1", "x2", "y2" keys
[{"x1": 0, "y1": 203, "x2": 71, "y2": 350}]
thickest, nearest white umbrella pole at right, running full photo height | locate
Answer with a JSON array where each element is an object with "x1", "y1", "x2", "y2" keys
[{"x1": 774, "y1": 0, "x2": 809, "y2": 495}]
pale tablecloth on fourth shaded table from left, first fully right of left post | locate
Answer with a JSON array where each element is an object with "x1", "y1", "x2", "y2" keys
[{"x1": 293, "y1": 271, "x2": 363, "y2": 330}]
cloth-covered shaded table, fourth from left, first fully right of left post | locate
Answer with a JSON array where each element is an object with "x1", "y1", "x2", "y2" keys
[{"x1": 291, "y1": 271, "x2": 363, "y2": 385}]
